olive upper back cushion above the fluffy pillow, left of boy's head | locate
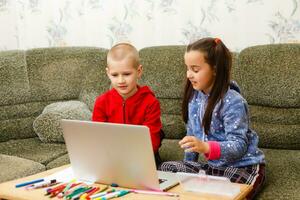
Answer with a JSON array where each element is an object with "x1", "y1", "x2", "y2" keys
[{"x1": 26, "y1": 47, "x2": 108, "y2": 101}]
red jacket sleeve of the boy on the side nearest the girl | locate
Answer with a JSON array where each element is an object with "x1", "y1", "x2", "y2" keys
[{"x1": 143, "y1": 99, "x2": 162, "y2": 153}]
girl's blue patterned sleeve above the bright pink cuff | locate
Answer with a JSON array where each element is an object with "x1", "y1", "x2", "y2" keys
[{"x1": 220, "y1": 97, "x2": 249, "y2": 163}]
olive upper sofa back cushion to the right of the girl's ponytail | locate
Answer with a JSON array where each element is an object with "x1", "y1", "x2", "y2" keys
[{"x1": 235, "y1": 44, "x2": 300, "y2": 108}]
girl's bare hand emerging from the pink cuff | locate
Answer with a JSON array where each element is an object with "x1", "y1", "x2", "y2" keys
[{"x1": 179, "y1": 136, "x2": 210, "y2": 153}]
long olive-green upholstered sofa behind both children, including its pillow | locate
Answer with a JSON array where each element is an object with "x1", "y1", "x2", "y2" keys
[{"x1": 0, "y1": 44, "x2": 300, "y2": 199}]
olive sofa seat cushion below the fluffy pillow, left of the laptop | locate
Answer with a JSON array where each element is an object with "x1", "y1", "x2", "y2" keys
[{"x1": 0, "y1": 137, "x2": 67, "y2": 165}]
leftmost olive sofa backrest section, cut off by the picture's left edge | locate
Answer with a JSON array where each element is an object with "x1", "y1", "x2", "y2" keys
[{"x1": 0, "y1": 50, "x2": 36, "y2": 142}]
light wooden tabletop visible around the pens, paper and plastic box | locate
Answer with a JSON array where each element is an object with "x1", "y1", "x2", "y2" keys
[{"x1": 0, "y1": 165, "x2": 252, "y2": 200}]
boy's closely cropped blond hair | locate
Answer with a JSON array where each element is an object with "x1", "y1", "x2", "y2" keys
[{"x1": 107, "y1": 43, "x2": 140, "y2": 68}]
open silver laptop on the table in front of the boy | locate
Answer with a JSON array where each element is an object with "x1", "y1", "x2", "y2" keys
[{"x1": 61, "y1": 119, "x2": 178, "y2": 191}]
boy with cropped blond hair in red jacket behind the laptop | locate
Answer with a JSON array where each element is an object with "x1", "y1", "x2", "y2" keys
[{"x1": 92, "y1": 43, "x2": 162, "y2": 166}]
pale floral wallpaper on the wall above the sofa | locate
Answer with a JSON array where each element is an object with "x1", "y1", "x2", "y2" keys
[{"x1": 0, "y1": 0, "x2": 300, "y2": 51}]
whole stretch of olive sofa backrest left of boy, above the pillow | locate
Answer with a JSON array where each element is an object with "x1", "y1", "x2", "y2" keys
[{"x1": 0, "y1": 47, "x2": 108, "y2": 142}]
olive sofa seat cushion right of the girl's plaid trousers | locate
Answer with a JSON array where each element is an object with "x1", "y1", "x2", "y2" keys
[{"x1": 257, "y1": 149, "x2": 300, "y2": 200}]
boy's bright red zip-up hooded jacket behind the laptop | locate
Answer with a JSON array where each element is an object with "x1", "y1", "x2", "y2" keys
[{"x1": 92, "y1": 86, "x2": 162, "y2": 153}]
